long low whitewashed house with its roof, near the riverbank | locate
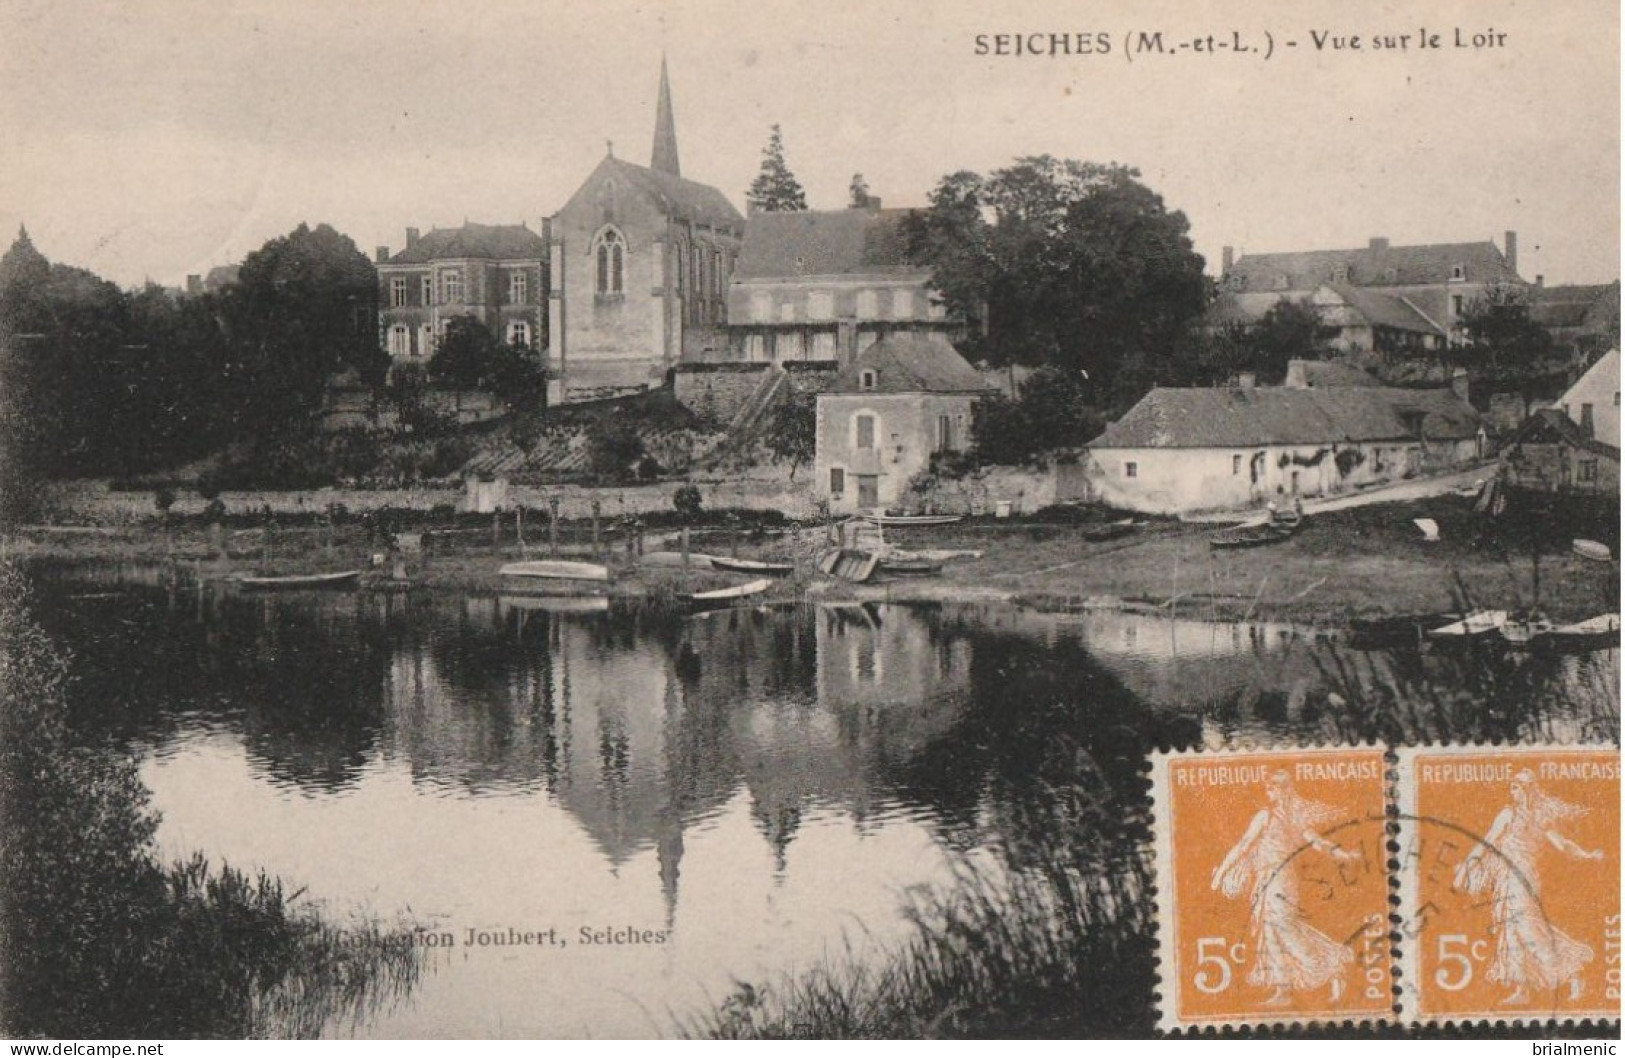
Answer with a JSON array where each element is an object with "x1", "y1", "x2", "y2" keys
[{"x1": 1084, "y1": 385, "x2": 1485, "y2": 514}]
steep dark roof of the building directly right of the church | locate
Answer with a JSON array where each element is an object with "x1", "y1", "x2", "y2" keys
[{"x1": 735, "y1": 210, "x2": 930, "y2": 280}]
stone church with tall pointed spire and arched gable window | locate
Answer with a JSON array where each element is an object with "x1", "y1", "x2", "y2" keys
[{"x1": 548, "y1": 60, "x2": 744, "y2": 401}]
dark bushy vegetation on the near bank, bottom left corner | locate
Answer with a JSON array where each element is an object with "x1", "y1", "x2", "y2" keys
[{"x1": 0, "y1": 567, "x2": 419, "y2": 1038}]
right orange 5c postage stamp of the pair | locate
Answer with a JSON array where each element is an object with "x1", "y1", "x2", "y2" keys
[{"x1": 1398, "y1": 746, "x2": 1620, "y2": 1022}]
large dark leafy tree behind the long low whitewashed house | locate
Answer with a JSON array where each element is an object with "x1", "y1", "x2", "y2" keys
[{"x1": 908, "y1": 154, "x2": 1209, "y2": 400}]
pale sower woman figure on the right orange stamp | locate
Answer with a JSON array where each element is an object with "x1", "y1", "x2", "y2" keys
[{"x1": 1454, "y1": 769, "x2": 1602, "y2": 1006}]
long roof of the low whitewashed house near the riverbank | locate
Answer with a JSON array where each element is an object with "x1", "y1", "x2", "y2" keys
[{"x1": 1089, "y1": 387, "x2": 1480, "y2": 449}]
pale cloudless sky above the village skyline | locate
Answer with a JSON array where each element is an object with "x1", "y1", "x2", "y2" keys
[{"x1": 0, "y1": 0, "x2": 1620, "y2": 286}]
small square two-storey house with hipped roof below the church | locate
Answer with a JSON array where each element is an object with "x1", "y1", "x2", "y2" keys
[{"x1": 814, "y1": 332, "x2": 988, "y2": 514}]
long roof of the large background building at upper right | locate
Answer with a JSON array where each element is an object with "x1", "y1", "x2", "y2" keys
[{"x1": 1225, "y1": 241, "x2": 1523, "y2": 291}]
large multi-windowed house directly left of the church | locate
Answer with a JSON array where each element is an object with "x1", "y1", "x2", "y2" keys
[{"x1": 377, "y1": 224, "x2": 548, "y2": 367}]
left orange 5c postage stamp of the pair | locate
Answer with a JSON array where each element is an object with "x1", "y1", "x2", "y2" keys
[{"x1": 1152, "y1": 746, "x2": 1394, "y2": 1030}]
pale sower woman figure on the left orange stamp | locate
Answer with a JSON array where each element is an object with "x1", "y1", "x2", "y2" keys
[{"x1": 1211, "y1": 770, "x2": 1359, "y2": 1006}]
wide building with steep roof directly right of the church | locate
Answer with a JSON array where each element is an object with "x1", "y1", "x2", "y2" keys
[{"x1": 728, "y1": 200, "x2": 964, "y2": 362}]
